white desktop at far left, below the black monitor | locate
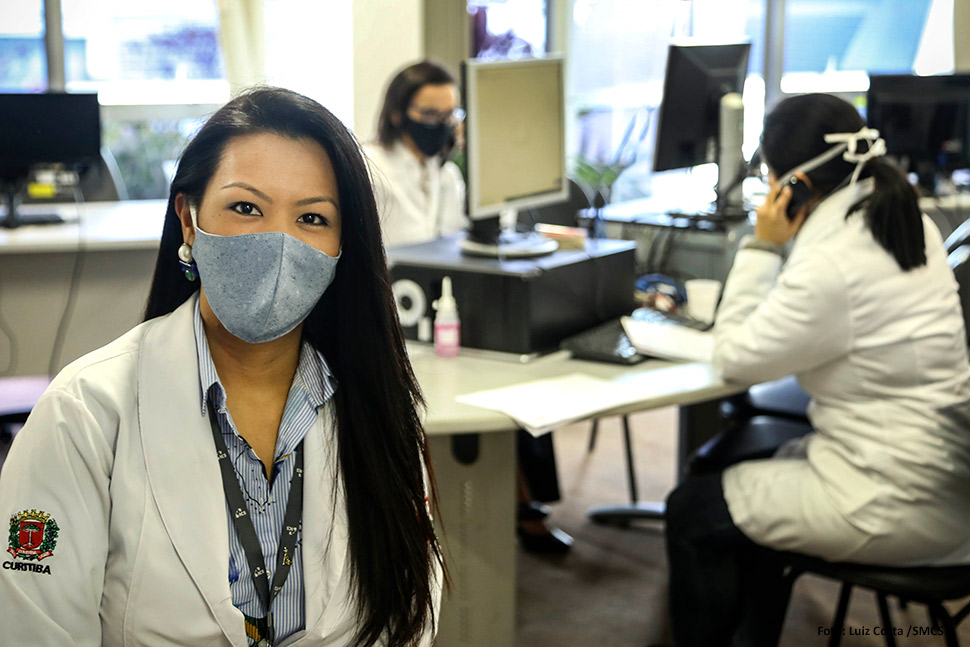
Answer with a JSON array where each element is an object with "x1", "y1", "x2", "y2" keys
[{"x1": 0, "y1": 200, "x2": 167, "y2": 254}]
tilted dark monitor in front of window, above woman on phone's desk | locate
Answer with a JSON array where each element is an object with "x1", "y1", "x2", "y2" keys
[{"x1": 653, "y1": 43, "x2": 751, "y2": 219}]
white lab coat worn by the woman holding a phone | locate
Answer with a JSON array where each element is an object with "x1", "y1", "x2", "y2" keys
[{"x1": 714, "y1": 180, "x2": 970, "y2": 565}]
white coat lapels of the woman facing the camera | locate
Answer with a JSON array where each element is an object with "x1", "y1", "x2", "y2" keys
[{"x1": 137, "y1": 294, "x2": 349, "y2": 647}]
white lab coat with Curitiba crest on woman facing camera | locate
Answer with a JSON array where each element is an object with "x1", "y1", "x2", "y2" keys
[{"x1": 0, "y1": 297, "x2": 440, "y2": 647}]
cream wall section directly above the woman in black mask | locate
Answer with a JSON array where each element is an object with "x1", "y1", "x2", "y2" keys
[{"x1": 353, "y1": 0, "x2": 424, "y2": 141}]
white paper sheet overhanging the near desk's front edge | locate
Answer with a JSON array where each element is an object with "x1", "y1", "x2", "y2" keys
[{"x1": 458, "y1": 373, "x2": 643, "y2": 436}]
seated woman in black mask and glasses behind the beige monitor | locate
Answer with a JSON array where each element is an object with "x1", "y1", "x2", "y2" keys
[{"x1": 364, "y1": 61, "x2": 572, "y2": 554}]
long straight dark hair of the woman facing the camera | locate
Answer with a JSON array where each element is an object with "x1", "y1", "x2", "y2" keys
[{"x1": 145, "y1": 88, "x2": 441, "y2": 646}]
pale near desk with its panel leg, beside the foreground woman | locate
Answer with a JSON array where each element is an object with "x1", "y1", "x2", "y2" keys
[{"x1": 408, "y1": 344, "x2": 743, "y2": 647}]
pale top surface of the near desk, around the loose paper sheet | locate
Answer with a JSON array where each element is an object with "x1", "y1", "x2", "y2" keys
[{"x1": 408, "y1": 342, "x2": 745, "y2": 435}]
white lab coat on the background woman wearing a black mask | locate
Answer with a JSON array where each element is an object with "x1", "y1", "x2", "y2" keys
[{"x1": 364, "y1": 141, "x2": 468, "y2": 247}]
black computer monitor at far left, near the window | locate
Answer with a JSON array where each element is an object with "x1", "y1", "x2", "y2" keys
[{"x1": 0, "y1": 92, "x2": 101, "y2": 227}]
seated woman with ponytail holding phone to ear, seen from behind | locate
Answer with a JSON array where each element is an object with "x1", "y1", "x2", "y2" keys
[{"x1": 667, "y1": 94, "x2": 970, "y2": 647}]
